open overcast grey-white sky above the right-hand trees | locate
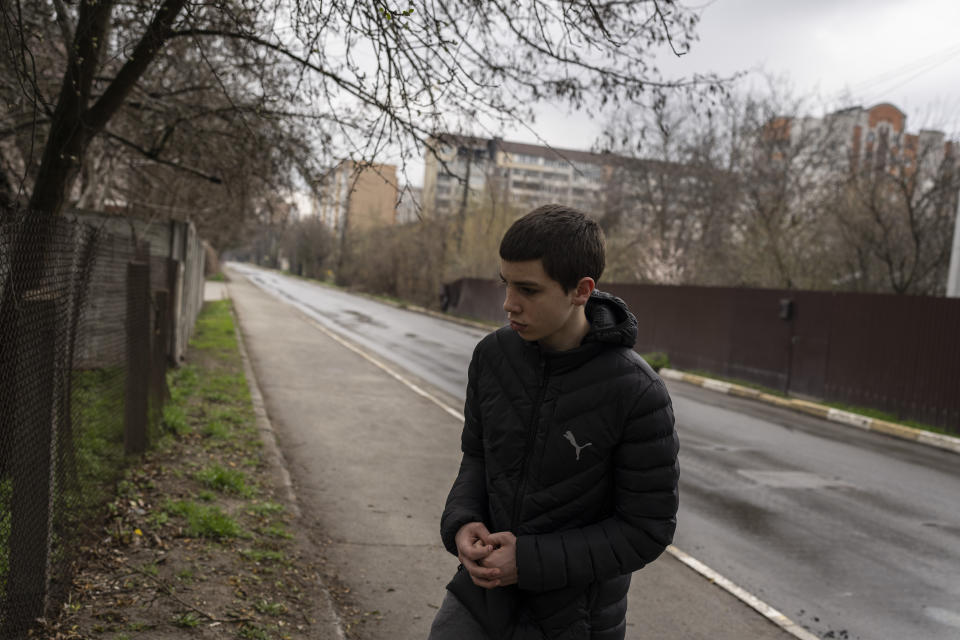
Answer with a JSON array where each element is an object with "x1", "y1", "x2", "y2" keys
[{"x1": 504, "y1": 0, "x2": 960, "y2": 157}]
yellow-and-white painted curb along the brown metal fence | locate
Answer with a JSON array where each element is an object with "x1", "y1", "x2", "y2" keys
[{"x1": 660, "y1": 368, "x2": 960, "y2": 454}]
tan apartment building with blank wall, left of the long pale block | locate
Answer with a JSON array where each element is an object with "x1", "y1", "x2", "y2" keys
[{"x1": 315, "y1": 160, "x2": 397, "y2": 239}]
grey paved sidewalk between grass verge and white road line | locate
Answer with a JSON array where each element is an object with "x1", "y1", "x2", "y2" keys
[{"x1": 227, "y1": 276, "x2": 792, "y2": 640}]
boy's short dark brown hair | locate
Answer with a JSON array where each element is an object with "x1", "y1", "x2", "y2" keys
[{"x1": 500, "y1": 204, "x2": 605, "y2": 291}]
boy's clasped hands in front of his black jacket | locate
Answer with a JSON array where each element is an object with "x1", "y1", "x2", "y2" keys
[{"x1": 456, "y1": 522, "x2": 517, "y2": 589}]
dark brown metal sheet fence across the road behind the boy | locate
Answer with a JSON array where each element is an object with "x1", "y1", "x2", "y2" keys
[{"x1": 445, "y1": 278, "x2": 960, "y2": 433}]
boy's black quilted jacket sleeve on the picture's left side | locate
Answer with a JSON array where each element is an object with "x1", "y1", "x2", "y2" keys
[{"x1": 440, "y1": 350, "x2": 487, "y2": 555}]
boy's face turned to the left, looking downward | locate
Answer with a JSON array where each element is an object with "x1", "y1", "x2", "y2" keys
[{"x1": 500, "y1": 260, "x2": 593, "y2": 350}]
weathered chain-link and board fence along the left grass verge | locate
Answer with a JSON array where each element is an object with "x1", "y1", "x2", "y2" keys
[{"x1": 0, "y1": 212, "x2": 203, "y2": 638}]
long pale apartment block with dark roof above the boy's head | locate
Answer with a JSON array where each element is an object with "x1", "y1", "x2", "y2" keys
[{"x1": 423, "y1": 134, "x2": 615, "y2": 217}]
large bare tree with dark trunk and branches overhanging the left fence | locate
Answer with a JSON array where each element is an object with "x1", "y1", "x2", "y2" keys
[{"x1": 2, "y1": 0, "x2": 720, "y2": 222}]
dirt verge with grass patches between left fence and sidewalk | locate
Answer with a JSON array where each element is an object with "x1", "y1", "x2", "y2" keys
[{"x1": 34, "y1": 301, "x2": 362, "y2": 640}]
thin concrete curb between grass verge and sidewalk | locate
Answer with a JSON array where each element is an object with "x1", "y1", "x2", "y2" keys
[{"x1": 224, "y1": 283, "x2": 346, "y2": 640}]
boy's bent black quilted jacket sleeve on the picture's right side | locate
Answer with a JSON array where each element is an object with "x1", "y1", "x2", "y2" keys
[{"x1": 517, "y1": 378, "x2": 679, "y2": 591}]
